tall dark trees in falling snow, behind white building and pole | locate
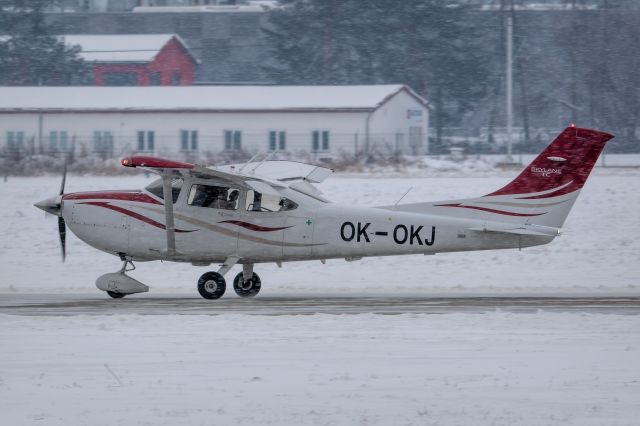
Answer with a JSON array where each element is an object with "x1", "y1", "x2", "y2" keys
[{"x1": 264, "y1": 0, "x2": 640, "y2": 152}]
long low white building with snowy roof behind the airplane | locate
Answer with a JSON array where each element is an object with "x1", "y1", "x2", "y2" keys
[{"x1": 0, "y1": 85, "x2": 429, "y2": 158}]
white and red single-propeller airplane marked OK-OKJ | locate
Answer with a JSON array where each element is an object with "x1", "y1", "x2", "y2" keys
[{"x1": 35, "y1": 125, "x2": 613, "y2": 299}]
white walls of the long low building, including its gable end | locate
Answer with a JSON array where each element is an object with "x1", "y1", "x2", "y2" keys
[{"x1": 0, "y1": 92, "x2": 428, "y2": 158}]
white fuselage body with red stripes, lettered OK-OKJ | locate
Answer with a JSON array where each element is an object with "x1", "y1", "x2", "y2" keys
[{"x1": 62, "y1": 179, "x2": 553, "y2": 264}]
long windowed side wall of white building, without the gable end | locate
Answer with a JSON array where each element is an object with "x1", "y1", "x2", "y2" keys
[{"x1": 0, "y1": 112, "x2": 366, "y2": 156}]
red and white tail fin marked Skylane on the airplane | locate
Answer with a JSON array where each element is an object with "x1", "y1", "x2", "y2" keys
[{"x1": 398, "y1": 126, "x2": 613, "y2": 228}]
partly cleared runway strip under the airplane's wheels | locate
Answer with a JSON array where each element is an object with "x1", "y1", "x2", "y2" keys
[{"x1": 0, "y1": 293, "x2": 640, "y2": 316}]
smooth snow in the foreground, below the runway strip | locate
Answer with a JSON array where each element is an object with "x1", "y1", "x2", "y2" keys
[{"x1": 0, "y1": 312, "x2": 640, "y2": 426}]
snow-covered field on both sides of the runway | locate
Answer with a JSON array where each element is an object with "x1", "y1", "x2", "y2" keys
[{"x1": 0, "y1": 165, "x2": 640, "y2": 426}]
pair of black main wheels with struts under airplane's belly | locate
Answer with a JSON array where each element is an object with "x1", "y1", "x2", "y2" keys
[{"x1": 198, "y1": 262, "x2": 261, "y2": 299}]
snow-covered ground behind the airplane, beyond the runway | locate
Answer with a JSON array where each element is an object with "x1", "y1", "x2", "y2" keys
[{"x1": 0, "y1": 169, "x2": 640, "y2": 297}]
